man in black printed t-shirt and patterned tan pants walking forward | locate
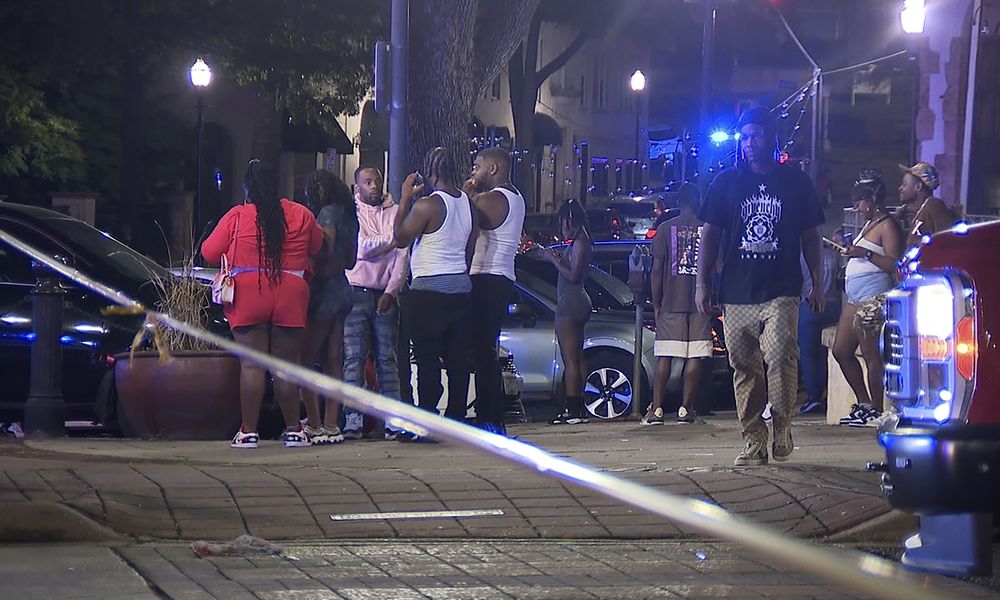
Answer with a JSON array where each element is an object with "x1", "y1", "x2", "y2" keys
[{"x1": 695, "y1": 106, "x2": 825, "y2": 466}]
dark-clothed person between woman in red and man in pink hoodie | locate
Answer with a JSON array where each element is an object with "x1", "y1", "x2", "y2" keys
[{"x1": 302, "y1": 170, "x2": 358, "y2": 446}]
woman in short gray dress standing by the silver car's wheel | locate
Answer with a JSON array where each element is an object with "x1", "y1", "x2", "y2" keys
[{"x1": 541, "y1": 198, "x2": 593, "y2": 425}]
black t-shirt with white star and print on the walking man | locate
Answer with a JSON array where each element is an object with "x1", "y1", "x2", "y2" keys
[{"x1": 698, "y1": 164, "x2": 823, "y2": 304}]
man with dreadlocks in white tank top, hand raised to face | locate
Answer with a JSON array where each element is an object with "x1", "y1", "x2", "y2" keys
[{"x1": 393, "y1": 147, "x2": 477, "y2": 441}]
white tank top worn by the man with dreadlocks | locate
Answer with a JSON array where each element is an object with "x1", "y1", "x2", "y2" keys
[{"x1": 410, "y1": 190, "x2": 472, "y2": 278}]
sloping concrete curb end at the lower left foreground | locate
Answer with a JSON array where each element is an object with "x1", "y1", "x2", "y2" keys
[{"x1": 0, "y1": 502, "x2": 131, "y2": 544}]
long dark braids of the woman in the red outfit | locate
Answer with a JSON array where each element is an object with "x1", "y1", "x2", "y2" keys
[{"x1": 243, "y1": 158, "x2": 287, "y2": 287}]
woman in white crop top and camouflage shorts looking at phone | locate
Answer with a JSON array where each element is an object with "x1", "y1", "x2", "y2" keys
[{"x1": 833, "y1": 171, "x2": 905, "y2": 427}]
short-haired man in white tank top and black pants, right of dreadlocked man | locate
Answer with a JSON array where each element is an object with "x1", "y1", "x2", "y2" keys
[{"x1": 465, "y1": 148, "x2": 524, "y2": 435}]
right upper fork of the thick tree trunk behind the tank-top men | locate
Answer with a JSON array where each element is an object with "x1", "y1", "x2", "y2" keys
[{"x1": 475, "y1": 0, "x2": 540, "y2": 91}]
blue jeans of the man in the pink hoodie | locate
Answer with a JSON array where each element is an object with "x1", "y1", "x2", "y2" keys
[{"x1": 344, "y1": 287, "x2": 399, "y2": 415}]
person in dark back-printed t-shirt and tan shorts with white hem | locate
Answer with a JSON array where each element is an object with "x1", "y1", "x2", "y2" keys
[{"x1": 640, "y1": 183, "x2": 712, "y2": 425}]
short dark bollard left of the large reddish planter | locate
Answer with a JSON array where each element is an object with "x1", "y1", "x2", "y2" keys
[{"x1": 24, "y1": 263, "x2": 66, "y2": 436}]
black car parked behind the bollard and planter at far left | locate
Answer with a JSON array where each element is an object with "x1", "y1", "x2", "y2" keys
[{"x1": 0, "y1": 202, "x2": 228, "y2": 426}]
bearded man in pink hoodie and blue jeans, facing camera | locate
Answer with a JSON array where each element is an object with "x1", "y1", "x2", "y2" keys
[{"x1": 344, "y1": 166, "x2": 409, "y2": 439}]
